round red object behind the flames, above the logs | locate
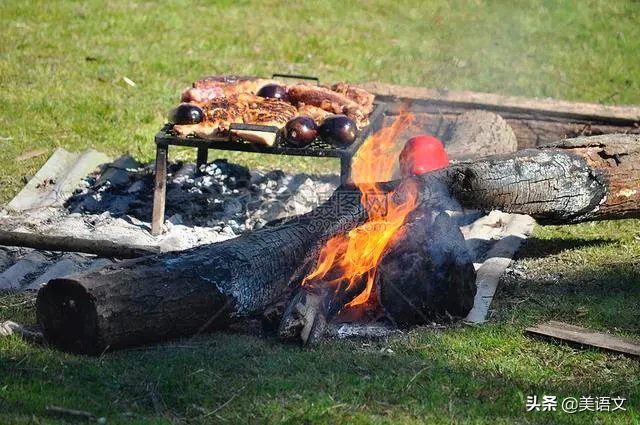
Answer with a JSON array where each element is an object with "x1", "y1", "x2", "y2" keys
[{"x1": 400, "y1": 135, "x2": 449, "y2": 177}]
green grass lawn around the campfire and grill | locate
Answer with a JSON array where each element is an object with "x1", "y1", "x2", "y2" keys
[{"x1": 0, "y1": 0, "x2": 640, "y2": 424}]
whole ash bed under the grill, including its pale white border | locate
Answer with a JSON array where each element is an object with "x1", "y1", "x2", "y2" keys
[{"x1": 23, "y1": 157, "x2": 339, "y2": 247}]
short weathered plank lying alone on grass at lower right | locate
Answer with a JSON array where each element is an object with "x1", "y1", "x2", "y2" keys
[{"x1": 525, "y1": 320, "x2": 640, "y2": 357}]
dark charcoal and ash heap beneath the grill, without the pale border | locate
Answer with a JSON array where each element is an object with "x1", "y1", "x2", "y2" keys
[{"x1": 66, "y1": 157, "x2": 340, "y2": 237}]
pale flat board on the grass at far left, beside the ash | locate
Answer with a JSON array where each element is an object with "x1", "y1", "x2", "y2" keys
[{"x1": 8, "y1": 148, "x2": 109, "y2": 211}]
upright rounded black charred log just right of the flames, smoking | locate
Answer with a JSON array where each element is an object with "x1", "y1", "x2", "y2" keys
[{"x1": 376, "y1": 211, "x2": 476, "y2": 326}]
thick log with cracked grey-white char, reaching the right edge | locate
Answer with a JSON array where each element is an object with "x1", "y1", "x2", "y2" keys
[{"x1": 428, "y1": 134, "x2": 640, "y2": 224}]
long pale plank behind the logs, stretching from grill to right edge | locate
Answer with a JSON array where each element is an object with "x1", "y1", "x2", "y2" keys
[{"x1": 360, "y1": 82, "x2": 640, "y2": 123}]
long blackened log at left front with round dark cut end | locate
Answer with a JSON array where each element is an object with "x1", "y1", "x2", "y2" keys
[{"x1": 36, "y1": 190, "x2": 366, "y2": 354}]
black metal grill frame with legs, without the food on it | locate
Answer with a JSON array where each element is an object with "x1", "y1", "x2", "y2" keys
[{"x1": 151, "y1": 74, "x2": 385, "y2": 235}]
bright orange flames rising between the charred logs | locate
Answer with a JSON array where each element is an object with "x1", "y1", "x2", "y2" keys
[{"x1": 303, "y1": 113, "x2": 417, "y2": 310}]
